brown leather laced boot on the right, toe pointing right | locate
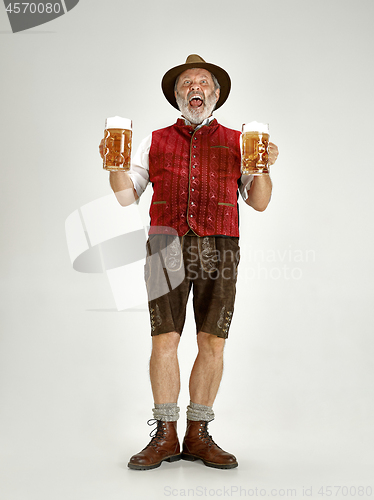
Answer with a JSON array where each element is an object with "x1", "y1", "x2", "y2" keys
[{"x1": 182, "y1": 420, "x2": 238, "y2": 469}]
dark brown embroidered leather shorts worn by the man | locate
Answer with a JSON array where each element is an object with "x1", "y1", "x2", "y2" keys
[{"x1": 145, "y1": 234, "x2": 240, "y2": 338}]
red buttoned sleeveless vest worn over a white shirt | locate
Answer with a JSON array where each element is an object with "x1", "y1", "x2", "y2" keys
[{"x1": 149, "y1": 119, "x2": 241, "y2": 237}]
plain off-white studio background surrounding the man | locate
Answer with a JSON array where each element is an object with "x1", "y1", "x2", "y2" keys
[{"x1": 0, "y1": 0, "x2": 374, "y2": 500}]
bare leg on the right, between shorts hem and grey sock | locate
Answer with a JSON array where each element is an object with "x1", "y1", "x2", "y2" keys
[{"x1": 190, "y1": 332, "x2": 225, "y2": 406}]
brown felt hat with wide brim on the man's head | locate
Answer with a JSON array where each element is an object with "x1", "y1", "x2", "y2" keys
[{"x1": 161, "y1": 54, "x2": 231, "y2": 109}]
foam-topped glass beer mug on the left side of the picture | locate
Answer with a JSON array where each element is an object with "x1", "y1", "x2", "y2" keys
[{"x1": 103, "y1": 116, "x2": 132, "y2": 172}]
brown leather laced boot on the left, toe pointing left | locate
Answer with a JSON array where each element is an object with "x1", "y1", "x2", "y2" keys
[{"x1": 128, "y1": 419, "x2": 181, "y2": 470}]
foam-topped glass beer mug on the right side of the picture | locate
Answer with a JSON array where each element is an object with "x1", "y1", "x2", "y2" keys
[{"x1": 242, "y1": 122, "x2": 269, "y2": 175}]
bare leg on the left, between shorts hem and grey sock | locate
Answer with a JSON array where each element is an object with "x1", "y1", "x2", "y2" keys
[{"x1": 149, "y1": 332, "x2": 180, "y2": 404}]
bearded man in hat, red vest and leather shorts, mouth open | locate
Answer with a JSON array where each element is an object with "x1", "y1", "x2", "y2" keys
[{"x1": 100, "y1": 55, "x2": 278, "y2": 470}]
